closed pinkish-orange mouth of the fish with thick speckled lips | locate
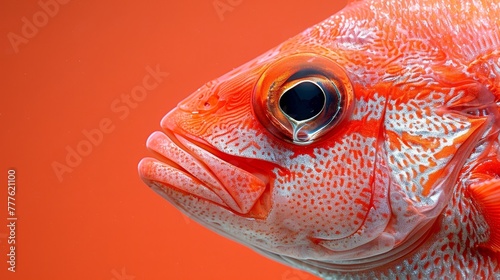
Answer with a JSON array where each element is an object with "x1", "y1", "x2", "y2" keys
[{"x1": 138, "y1": 129, "x2": 273, "y2": 218}]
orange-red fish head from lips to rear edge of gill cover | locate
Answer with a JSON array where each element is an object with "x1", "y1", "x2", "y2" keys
[{"x1": 139, "y1": 0, "x2": 496, "y2": 270}]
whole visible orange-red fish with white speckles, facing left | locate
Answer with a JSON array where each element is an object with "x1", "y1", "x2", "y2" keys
[{"x1": 138, "y1": 0, "x2": 500, "y2": 279}]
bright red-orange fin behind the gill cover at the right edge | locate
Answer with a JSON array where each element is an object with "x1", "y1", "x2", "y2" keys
[{"x1": 469, "y1": 178, "x2": 500, "y2": 252}]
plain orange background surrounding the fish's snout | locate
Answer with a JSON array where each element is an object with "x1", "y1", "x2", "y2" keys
[{"x1": 0, "y1": 0, "x2": 346, "y2": 280}]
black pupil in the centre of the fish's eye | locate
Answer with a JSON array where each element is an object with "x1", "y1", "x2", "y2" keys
[{"x1": 280, "y1": 82, "x2": 325, "y2": 121}]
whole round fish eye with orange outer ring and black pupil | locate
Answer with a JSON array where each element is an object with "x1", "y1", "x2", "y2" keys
[{"x1": 252, "y1": 53, "x2": 354, "y2": 145}]
